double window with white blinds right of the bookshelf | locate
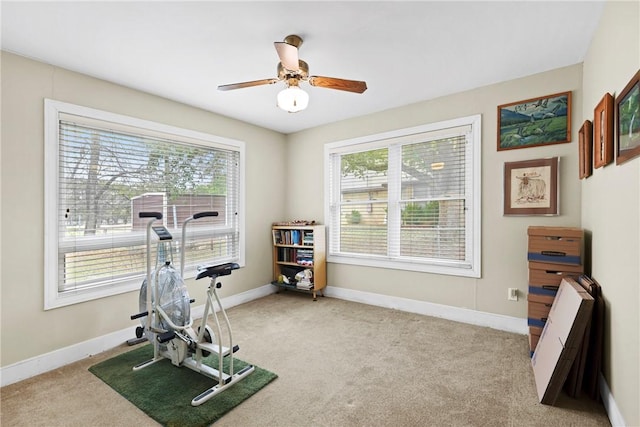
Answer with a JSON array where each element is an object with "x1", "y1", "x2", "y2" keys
[{"x1": 325, "y1": 115, "x2": 481, "y2": 277}]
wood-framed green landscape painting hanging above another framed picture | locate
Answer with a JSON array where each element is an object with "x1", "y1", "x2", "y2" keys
[{"x1": 498, "y1": 92, "x2": 571, "y2": 151}]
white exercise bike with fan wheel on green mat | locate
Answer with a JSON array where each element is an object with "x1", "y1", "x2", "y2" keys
[{"x1": 131, "y1": 212, "x2": 255, "y2": 406}]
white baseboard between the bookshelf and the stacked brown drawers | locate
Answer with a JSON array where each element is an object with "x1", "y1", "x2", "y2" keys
[{"x1": 324, "y1": 287, "x2": 529, "y2": 335}]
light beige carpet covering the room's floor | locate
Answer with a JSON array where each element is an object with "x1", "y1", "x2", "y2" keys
[{"x1": 0, "y1": 292, "x2": 610, "y2": 426}]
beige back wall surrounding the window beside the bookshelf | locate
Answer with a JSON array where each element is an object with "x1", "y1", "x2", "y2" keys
[{"x1": 287, "y1": 65, "x2": 582, "y2": 318}]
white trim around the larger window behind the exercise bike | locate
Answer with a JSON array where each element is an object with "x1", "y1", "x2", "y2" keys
[{"x1": 44, "y1": 99, "x2": 246, "y2": 310}]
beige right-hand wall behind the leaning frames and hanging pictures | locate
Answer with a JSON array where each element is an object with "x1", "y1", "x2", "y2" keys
[{"x1": 581, "y1": 1, "x2": 640, "y2": 426}]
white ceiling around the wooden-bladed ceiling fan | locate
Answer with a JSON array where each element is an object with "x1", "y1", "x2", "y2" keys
[{"x1": 1, "y1": 0, "x2": 603, "y2": 133}]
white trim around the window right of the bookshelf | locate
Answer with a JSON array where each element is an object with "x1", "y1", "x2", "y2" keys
[{"x1": 324, "y1": 114, "x2": 482, "y2": 278}]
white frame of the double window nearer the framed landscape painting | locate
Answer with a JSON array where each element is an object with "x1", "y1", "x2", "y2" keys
[{"x1": 324, "y1": 114, "x2": 482, "y2": 278}]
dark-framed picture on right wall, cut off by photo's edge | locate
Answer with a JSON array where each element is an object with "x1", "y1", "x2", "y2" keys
[{"x1": 615, "y1": 70, "x2": 640, "y2": 165}]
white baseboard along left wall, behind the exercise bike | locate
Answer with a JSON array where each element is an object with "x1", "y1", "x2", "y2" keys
[{"x1": 0, "y1": 284, "x2": 275, "y2": 387}]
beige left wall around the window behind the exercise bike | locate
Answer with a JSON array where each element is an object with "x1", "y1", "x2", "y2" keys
[{"x1": 0, "y1": 52, "x2": 286, "y2": 366}]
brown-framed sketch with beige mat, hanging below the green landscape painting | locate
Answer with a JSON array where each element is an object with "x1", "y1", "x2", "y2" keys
[{"x1": 504, "y1": 157, "x2": 560, "y2": 216}]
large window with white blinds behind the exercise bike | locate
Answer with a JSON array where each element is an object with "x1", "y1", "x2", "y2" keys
[{"x1": 45, "y1": 99, "x2": 244, "y2": 309}]
